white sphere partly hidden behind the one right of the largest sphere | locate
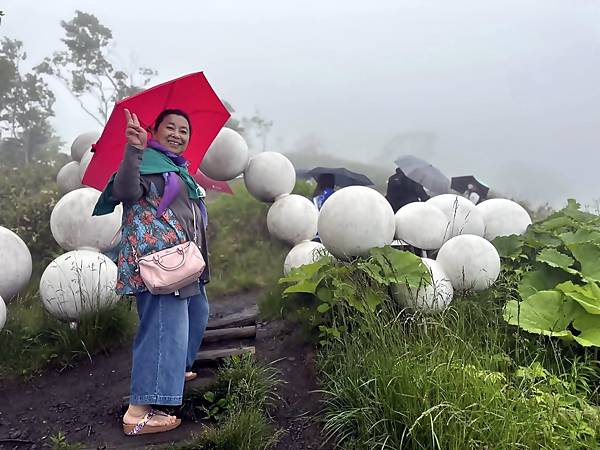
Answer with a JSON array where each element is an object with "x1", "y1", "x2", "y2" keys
[{"x1": 426, "y1": 194, "x2": 485, "y2": 241}]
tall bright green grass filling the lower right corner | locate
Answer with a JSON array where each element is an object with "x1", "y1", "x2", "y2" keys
[{"x1": 319, "y1": 296, "x2": 600, "y2": 449}]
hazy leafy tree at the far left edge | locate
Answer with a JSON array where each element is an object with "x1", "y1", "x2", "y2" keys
[{"x1": 0, "y1": 37, "x2": 55, "y2": 167}]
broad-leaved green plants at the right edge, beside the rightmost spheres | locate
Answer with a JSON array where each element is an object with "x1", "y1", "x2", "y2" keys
[{"x1": 494, "y1": 200, "x2": 600, "y2": 347}]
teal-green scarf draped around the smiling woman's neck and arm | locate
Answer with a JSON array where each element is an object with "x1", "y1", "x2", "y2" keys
[{"x1": 92, "y1": 147, "x2": 206, "y2": 216}]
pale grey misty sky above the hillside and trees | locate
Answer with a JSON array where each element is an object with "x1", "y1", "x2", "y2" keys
[{"x1": 0, "y1": 0, "x2": 600, "y2": 205}]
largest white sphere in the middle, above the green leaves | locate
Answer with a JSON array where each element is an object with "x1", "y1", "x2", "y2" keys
[{"x1": 318, "y1": 186, "x2": 396, "y2": 259}]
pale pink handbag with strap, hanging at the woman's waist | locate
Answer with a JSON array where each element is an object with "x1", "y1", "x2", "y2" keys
[{"x1": 133, "y1": 204, "x2": 206, "y2": 295}]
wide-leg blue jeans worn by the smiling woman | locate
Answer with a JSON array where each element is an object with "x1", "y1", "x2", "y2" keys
[{"x1": 129, "y1": 286, "x2": 208, "y2": 405}]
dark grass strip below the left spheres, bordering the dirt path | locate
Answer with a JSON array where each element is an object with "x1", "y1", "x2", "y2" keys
[{"x1": 0, "y1": 294, "x2": 137, "y2": 379}]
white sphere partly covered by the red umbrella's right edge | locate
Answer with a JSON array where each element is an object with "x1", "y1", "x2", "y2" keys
[{"x1": 200, "y1": 128, "x2": 249, "y2": 181}]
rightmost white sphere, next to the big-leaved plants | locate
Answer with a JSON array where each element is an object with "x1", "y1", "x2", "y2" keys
[{"x1": 476, "y1": 198, "x2": 531, "y2": 241}]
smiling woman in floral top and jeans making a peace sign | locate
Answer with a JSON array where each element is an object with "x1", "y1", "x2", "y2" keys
[{"x1": 94, "y1": 109, "x2": 209, "y2": 435}]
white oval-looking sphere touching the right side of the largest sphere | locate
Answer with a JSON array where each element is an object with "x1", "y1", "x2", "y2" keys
[{"x1": 396, "y1": 202, "x2": 450, "y2": 250}]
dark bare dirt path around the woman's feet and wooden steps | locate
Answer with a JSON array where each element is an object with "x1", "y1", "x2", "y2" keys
[{"x1": 0, "y1": 293, "x2": 321, "y2": 450}]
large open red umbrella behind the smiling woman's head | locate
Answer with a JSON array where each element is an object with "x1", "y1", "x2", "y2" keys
[{"x1": 82, "y1": 72, "x2": 230, "y2": 190}]
